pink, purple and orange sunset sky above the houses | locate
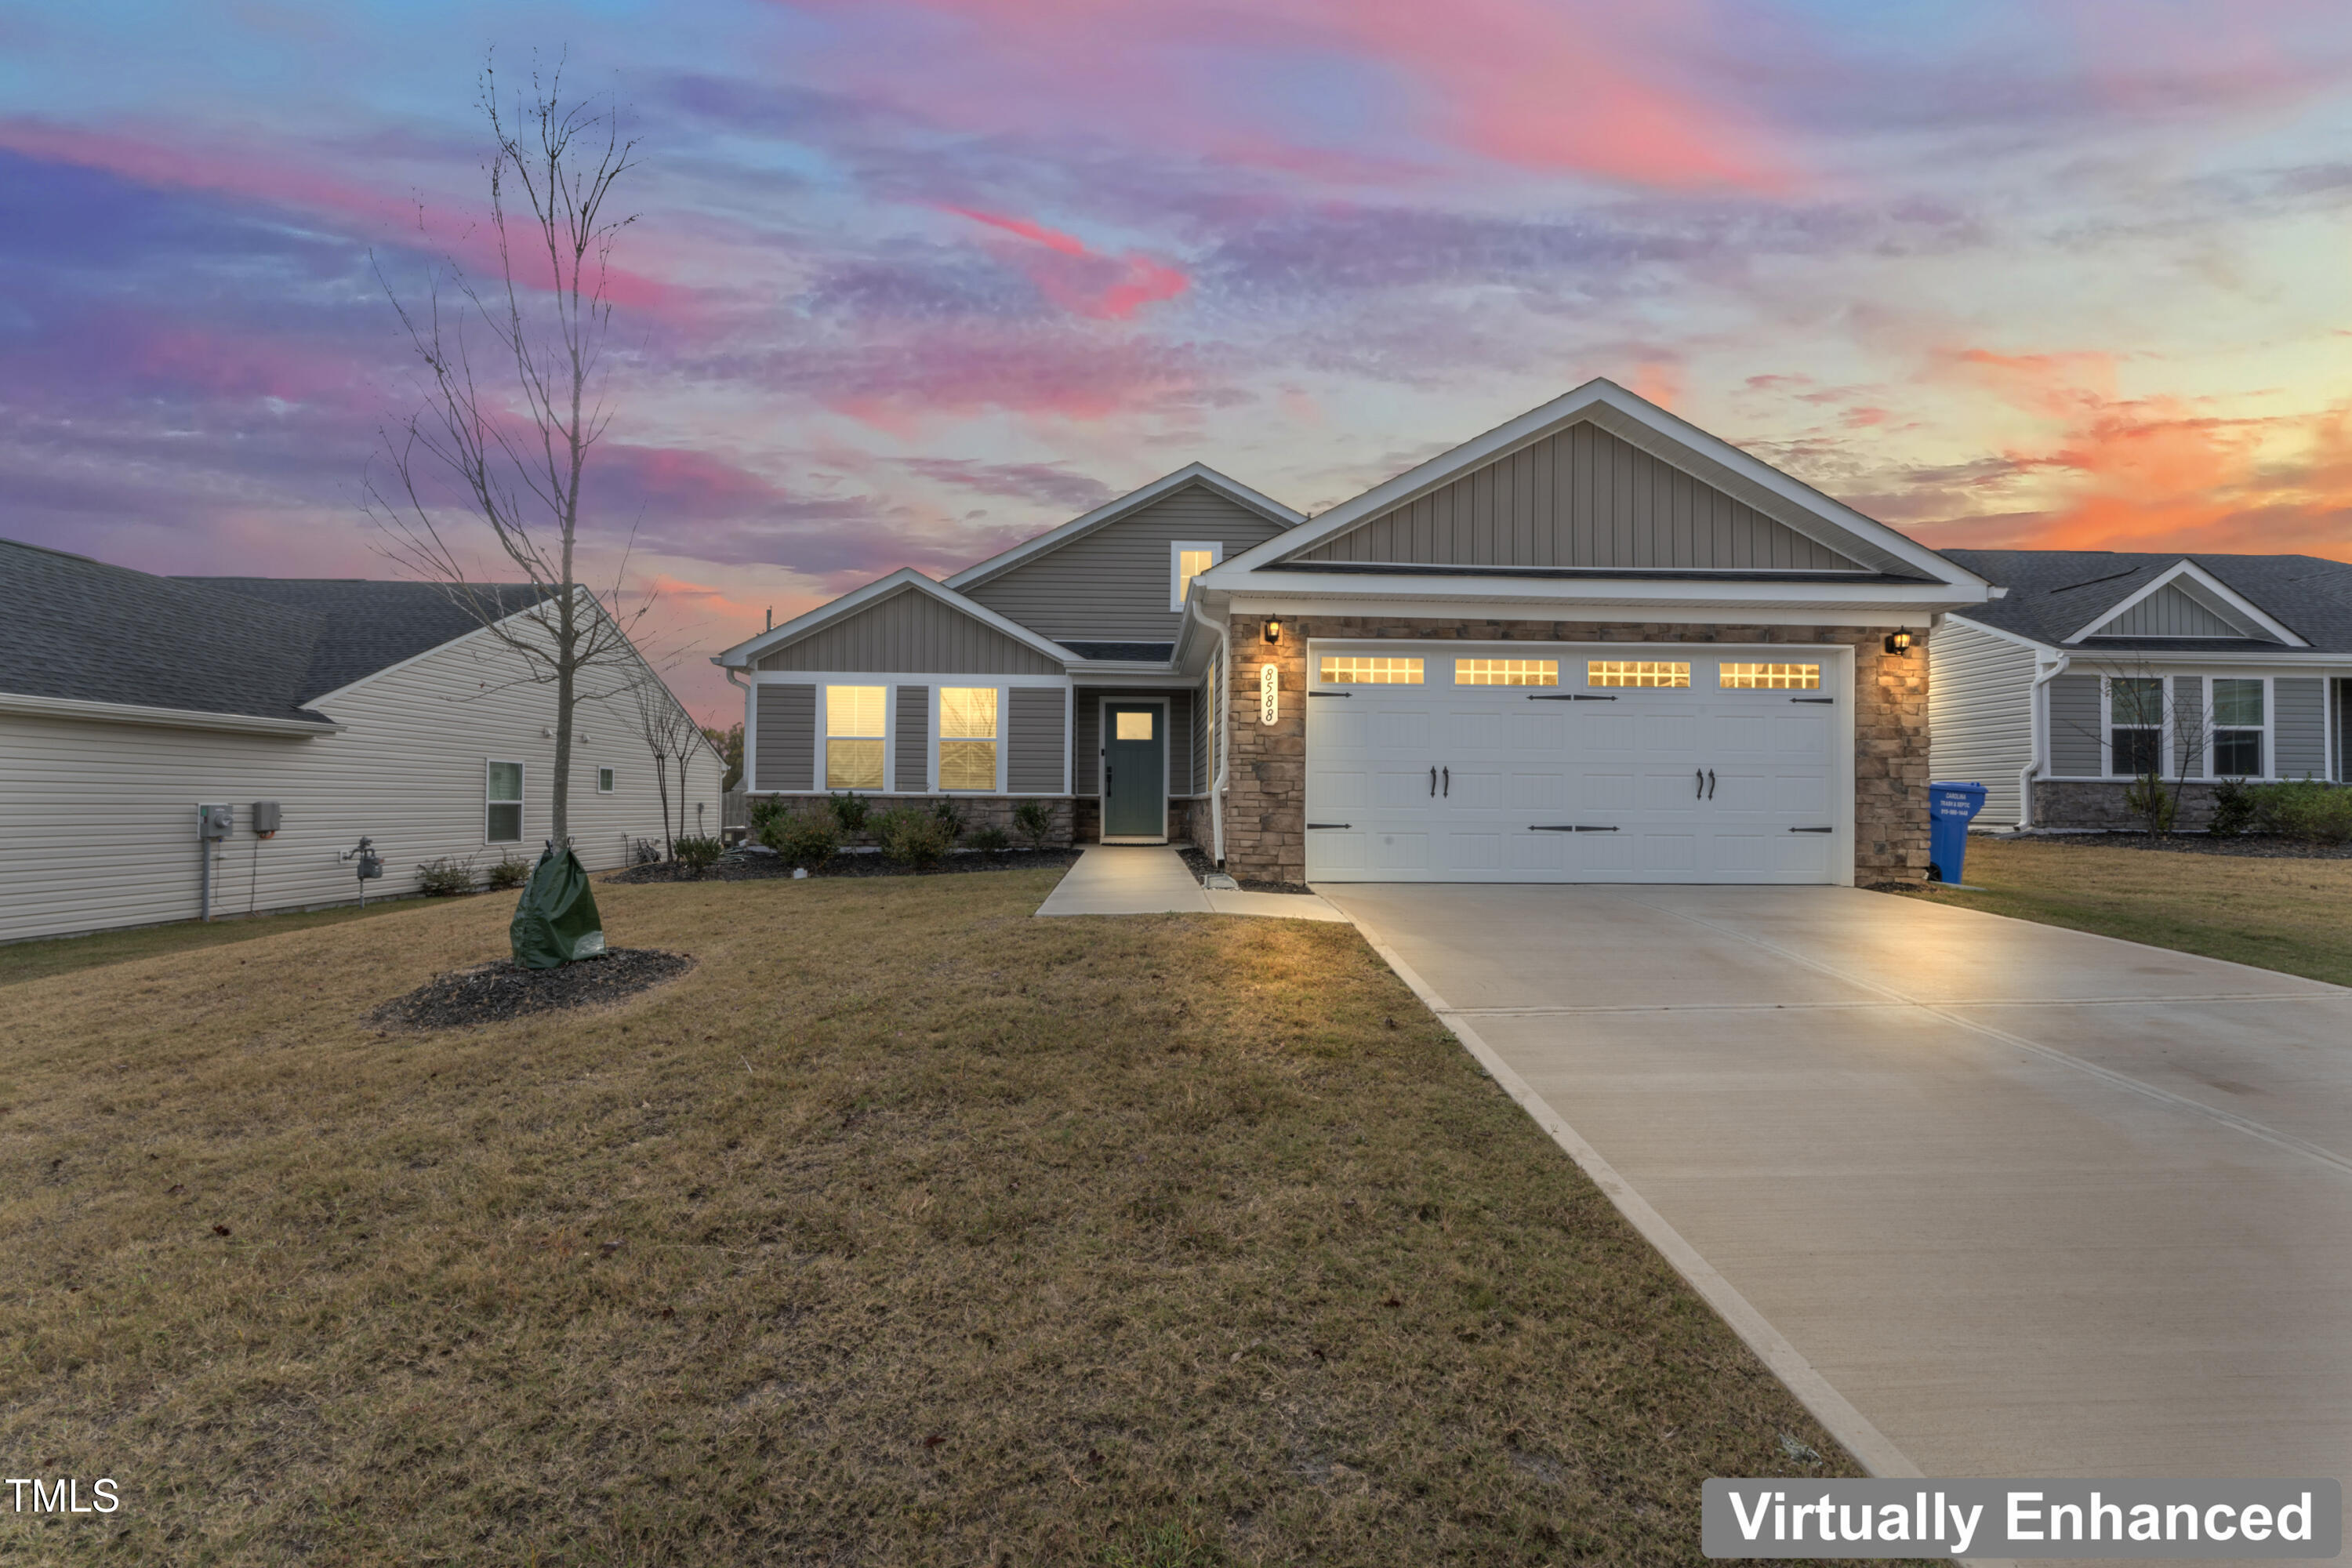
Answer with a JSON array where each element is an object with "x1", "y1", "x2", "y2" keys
[{"x1": 0, "y1": 0, "x2": 2352, "y2": 717}]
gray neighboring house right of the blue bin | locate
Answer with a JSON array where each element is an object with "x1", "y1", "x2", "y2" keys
[{"x1": 1929, "y1": 550, "x2": 2352, "y2": 827}]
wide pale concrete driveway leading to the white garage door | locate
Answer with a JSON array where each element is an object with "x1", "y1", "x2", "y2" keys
[{"x1": 1319, "y1": 886, "x2": 2352, "y2": 1476}]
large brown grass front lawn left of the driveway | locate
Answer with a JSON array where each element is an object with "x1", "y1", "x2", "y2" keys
[{"x1": 0, "y1": 867, "x2": 1872, "y2": 1566}]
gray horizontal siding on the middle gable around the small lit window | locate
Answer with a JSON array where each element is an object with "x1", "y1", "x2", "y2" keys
[{"x1": 964, "y1": 485, "x2": 1282, "y2": 642}]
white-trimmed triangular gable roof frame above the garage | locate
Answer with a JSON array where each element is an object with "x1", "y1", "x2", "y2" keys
[{"x1": 1204, "y1": 379, "x2": 1983, "y2": 588}]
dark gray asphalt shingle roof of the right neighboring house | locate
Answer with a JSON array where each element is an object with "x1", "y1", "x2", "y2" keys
[{"x1": 1943, "y1": 550, "x2": 2352, "y2": 654}]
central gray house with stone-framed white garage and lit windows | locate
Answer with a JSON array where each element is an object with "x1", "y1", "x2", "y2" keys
[{"x1": 717, "y1": 381, "x2": 1994, "y2": 881}]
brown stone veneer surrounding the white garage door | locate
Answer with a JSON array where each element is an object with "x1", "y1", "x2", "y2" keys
[{"x1": 1225, "y1": 614, "x2": 1926, "y2": 881}]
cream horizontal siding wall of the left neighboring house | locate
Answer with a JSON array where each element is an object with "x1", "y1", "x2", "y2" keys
[{"x1": 0, "y1": 633, "x2": 722, "y2": 940}]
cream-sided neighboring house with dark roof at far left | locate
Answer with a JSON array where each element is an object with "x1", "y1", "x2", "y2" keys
[{"x1": 0, "y1": 541, "x2": 720, "y2": 940}]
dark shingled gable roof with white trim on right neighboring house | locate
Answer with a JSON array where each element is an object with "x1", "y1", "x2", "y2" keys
[{"x1": 1945, "y1": 550, "x2": 2352, "y2": 654}]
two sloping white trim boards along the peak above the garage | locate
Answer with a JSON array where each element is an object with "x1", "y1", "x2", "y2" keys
[{"x1": 1211, "y1": 376, "x2": 1990, "y2": 602}]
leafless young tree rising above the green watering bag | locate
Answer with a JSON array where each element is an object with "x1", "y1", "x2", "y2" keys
[{"x1": 365, "y1": 64, "x2": 652, "y2": 844}]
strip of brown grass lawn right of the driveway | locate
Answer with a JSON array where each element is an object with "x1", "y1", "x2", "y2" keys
[{"x1": 1912, "y1": 837, "x2": 2352, "y2": 985}]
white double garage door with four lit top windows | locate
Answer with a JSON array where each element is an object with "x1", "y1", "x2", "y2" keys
[{"x1": 1305, "y1": 644, "x2": 1853, "y2": 881}]
